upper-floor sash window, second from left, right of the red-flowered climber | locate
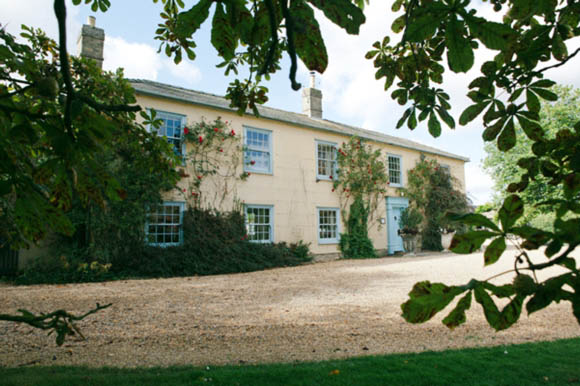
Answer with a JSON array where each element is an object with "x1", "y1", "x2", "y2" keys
[{"x1": 244, "y1": 126, "x2": 273, "y2": 174}]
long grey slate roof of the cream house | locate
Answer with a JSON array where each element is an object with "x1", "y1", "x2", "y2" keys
[{"x1": 130, "y1": 79, "x2": 469, "y2": 162}]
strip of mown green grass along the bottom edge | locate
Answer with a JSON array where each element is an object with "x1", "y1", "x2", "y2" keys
[{"x1": 0, "y1": 338, "x2": 580, "y2": 386}]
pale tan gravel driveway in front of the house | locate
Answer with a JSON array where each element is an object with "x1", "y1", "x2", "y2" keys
[{"x1": 0, "y1": 247, "x2": 580, "y2": 367}]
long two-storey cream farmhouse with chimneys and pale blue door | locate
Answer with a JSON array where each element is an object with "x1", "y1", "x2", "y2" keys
[{"x1": 5, "y1": 17, "x2": 469, "y2": 274}]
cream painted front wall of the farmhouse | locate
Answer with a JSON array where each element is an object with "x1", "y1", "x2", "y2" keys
[{"x1": 138, "y1": 95, "x2": 465, "y2": 254}]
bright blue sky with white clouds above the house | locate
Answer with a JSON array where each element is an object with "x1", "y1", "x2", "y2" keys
[{"x1": 0, "y1": 0, "x2": 580, "y2": 205}]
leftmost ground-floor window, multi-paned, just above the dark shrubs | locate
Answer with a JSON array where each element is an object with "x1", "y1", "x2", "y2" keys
[{"x1": 146, "y1": 202, "x2": 185, "y2": 247}]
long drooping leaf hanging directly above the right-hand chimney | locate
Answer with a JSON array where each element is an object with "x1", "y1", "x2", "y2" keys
[{"x1": 289, "y1": 0, "x2": 328, "y2": 74}]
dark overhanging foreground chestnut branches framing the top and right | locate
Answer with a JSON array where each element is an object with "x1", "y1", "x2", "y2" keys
[{"x1": 2, "y1": 0, "x2": 580, "y2": 338}]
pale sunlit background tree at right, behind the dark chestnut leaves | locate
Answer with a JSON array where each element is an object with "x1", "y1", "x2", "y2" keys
[{"x1": 483, "y1": 86, "x2": 580, "y2": 231}]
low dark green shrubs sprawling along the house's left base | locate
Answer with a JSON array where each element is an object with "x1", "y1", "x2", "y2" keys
[{"x1": 16, "y1": 209, "x2": 311, "y2": 284}]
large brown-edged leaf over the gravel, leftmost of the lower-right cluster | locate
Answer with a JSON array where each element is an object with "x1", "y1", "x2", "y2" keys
[{"x1": 401, "y1": 281, "x2": 465, "y2": 323}]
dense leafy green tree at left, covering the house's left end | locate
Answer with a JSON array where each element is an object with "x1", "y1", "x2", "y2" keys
[{"x1": 0, "y1": 17, "x2": 176, "y2": 345}]
